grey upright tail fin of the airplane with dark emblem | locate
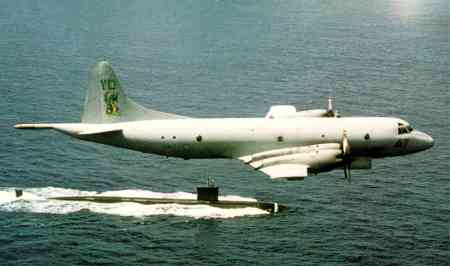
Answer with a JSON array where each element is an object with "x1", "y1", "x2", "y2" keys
[{"x1": 81, "y1": 61, "x2": 187, "y2": 123}]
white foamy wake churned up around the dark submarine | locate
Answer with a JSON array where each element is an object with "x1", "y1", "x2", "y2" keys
[{"x1": 0, "y1": 187, "x2": 268, "y2": 218}]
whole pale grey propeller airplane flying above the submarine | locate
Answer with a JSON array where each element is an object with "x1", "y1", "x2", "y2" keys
[{"x1": 15, "y1": 61, "x2": 434, "y2": 181}]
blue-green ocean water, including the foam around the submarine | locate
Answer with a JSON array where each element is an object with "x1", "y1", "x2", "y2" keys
[{"x1": 0, "y1": 0, "x2": 450, "y2": 265}]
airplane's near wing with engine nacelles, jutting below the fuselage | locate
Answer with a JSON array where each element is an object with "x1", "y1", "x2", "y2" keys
[{"x1": 238, "y1": 143, "x2": 341, "y2": 180}]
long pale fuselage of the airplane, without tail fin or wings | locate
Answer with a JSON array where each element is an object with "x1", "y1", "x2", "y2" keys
[{"x1": 71, "y1": 117, "x2": 433, "y2": 159}]
